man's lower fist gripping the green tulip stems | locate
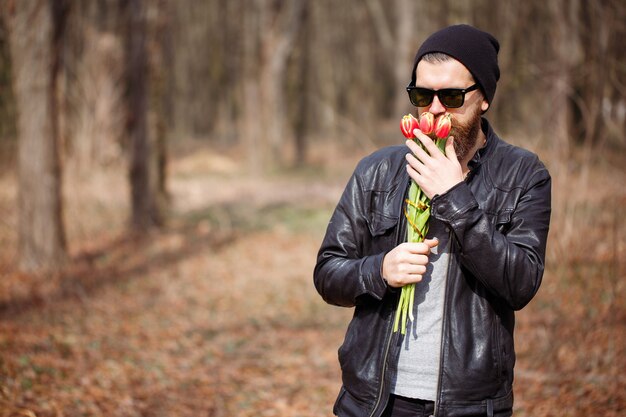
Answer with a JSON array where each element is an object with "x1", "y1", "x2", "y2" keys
[{"x1": 382, "y1": 239, "x2": 439, "y2": 288}]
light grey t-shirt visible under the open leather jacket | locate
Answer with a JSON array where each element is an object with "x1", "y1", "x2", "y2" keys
[{"x1": 392, "y1": 217, "x2": 450, "y2": 401}]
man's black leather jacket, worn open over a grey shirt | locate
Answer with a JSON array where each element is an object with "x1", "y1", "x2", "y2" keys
[{"x1": 314, "y1": 119, "x2": 551, "y2": 417}]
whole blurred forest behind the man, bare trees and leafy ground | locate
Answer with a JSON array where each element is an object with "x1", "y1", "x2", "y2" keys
[{"x1": 0, "y1": 0, "x2": 626, "y2": 417}]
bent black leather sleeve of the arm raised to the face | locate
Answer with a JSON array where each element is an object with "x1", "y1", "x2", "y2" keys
[{"x1": 431, "y1": 165, "x2": 551, "y2": 310}]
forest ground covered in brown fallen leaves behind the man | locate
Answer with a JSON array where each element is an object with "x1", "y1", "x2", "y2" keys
[{"x1": 0, "y1": 141, "x2": 626, "y2": 417}]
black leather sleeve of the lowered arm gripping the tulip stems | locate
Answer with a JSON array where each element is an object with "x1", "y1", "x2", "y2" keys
[{"x1": 313, "y1": 168, "x2": 387, "y2": 307}]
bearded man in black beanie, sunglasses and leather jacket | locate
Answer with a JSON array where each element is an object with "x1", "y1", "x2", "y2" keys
[{"x1": 314, "y1": 25, "x2": 551, "y2": 417}]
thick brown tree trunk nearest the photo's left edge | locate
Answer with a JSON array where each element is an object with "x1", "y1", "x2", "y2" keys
[{"x1": 8, "y1": 0, "x2": 66, "y2": 271}]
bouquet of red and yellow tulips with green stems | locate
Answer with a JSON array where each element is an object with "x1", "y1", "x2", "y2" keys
[{"x1": 393, "y1": 112, "x2": 452, "y2": 334}]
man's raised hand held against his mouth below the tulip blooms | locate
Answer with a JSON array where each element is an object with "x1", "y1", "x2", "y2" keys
[{"x1": 406, "y1": 129, "x2": 463, "y2": 198}]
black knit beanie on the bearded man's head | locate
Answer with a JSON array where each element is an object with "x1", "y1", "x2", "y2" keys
[{"x1": 411, "y1": 25, "x2": 500, "y2": 104}]
